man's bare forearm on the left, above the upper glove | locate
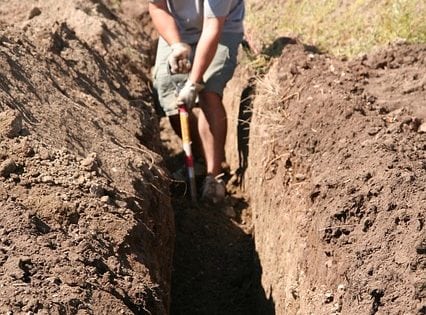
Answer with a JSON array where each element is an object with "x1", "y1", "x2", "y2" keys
[{"x1": 148, "y1": 0, "x2": 181, "y2": 45}]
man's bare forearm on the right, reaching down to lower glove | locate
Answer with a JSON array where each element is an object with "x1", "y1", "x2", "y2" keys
[{"x1": 189, "y1": 17, "x2": 226, "y2": 83}]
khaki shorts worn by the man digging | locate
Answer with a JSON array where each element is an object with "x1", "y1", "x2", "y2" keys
[{"x1": 153, "y1": 33, "x2": 243, "y2": 116}]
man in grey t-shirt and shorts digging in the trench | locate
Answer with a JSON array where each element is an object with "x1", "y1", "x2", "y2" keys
[{"x1": 149, "y1": 0, "x2": 244, "y2": 204}]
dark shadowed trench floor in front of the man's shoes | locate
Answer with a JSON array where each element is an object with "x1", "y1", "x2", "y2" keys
[{"x1": 171, "y1": 188, "x2": 255, "y2": 314}]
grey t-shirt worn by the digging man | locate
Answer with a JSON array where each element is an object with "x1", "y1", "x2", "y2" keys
[{"x1": 149, "y1": 0, "x2": 244, "y2": 43}]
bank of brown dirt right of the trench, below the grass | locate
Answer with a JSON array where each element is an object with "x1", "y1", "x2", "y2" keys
[{"x1": 246, "y1": 44, "x2": 426, "y2": 314}]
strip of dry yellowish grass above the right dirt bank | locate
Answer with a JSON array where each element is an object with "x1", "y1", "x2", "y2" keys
[{"x1": 246, "y1": 0, "x2": 426, "y2": 57}]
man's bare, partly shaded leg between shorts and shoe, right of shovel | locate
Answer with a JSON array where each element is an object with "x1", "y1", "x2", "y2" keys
[{"x1": 198, "y1": 92, "x2": 227, "y2": 176}]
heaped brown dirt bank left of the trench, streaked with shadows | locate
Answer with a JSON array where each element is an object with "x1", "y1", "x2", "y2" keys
[{"x1": 0, "y1": 0, "x2": 174, "y2": 314}]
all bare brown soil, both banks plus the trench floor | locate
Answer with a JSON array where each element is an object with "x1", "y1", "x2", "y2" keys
[{"x1": 0, "y1": 0, "x2": 426, "y2": 314}]
